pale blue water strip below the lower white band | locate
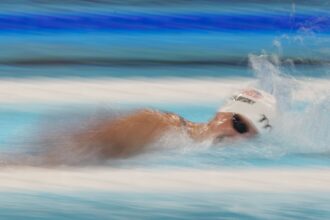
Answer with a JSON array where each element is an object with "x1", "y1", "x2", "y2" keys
[{"x1": 0, "y1": 192, "x2": 330, "y2": 220}]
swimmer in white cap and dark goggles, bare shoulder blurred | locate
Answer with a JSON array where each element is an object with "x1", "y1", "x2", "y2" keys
[{"x1": 44, "y1": 88, "x2": 276, "y2": 162}]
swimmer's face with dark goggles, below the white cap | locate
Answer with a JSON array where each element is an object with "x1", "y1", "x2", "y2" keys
[{"x1": 208, "y1": 112, "x2": 257, "y2": 143}]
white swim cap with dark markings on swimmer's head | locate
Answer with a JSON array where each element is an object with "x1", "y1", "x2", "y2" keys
[{"x1": 219, "y1": 88, "x2": 277, "y2": 133}]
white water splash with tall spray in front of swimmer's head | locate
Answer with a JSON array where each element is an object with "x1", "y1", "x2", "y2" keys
[{"x1": 249, "y1": 54, "x2": 330, "y2": 155}]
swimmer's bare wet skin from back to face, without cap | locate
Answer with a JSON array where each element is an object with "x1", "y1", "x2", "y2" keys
[{"x1": 63, "y1": 110, "x2": 257, "y2": 159}]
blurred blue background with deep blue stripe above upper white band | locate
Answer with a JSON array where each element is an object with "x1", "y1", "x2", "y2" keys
[{"x1": 0, "y1": 0, "x2": 330, "y2": 77}]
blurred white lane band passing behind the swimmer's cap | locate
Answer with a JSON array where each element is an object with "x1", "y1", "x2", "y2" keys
[{"x1": 0, "y1": 78, "x2": 330, "y2": 104}]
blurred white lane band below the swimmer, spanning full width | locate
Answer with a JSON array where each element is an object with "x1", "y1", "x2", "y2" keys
[{"x1": 0, "y1": 167, "x2": 330, "y2": 192}]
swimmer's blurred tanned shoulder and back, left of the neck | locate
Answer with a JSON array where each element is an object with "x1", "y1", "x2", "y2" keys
[{"x1": 71, "y1": 110, "x2": 181, "y2": 158}]
